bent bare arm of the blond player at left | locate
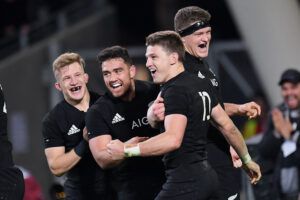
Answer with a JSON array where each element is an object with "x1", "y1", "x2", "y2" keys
[{"x1": 45, "y1": 146, "x2": 81, "y2": 176}]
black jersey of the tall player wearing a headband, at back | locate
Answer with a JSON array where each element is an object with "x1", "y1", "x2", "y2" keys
[{"x1": 184, "y1": 52, "x2": 232, "y2": 166}]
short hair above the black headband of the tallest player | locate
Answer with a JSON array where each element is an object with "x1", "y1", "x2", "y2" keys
[{"x1": 174, "y1": 6, "x2": 211, "y2": 32}]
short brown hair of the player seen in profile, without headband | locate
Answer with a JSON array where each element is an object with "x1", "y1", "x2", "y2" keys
[{"x1": 146, "y1": 31, "x2": 185, "y2": 62}]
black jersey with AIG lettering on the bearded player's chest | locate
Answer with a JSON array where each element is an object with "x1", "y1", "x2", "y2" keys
[{"x1": 86, "y1": 80, "x2": 164, "y2": 182}]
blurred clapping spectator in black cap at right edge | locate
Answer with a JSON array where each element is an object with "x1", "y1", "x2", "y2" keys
[{"x1": 254, "y1": 69, "x2": 300, "y2": 200}]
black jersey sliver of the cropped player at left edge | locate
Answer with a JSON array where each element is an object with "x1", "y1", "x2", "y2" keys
[{"x1": 0, "y1": 85, "x2": 14, "y2": 168}]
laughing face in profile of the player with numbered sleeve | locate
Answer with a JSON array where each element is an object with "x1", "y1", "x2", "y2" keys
[{"x1": 146, "y1": 45, "x2": 172, "y2": 84}]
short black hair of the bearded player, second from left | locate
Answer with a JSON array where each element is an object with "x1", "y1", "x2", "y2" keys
[{"x1": 97, "y1": 46, "x2": 133, "y2": 66}]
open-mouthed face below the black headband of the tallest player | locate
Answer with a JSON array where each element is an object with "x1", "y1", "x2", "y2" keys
[{"x1": 182, "y1": 27, "x2": 211, "y2": 59}]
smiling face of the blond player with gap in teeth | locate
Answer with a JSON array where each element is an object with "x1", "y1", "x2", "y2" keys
[{"x1": 55, "y1": 62, "x2": 88, "y2": 105}]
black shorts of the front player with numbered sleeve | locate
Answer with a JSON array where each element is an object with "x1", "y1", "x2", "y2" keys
[{"x1": 155, "y1": 164, "x2": 218, "y2": 200}]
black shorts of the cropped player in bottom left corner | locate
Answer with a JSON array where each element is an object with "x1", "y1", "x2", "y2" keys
[{"x1": 0, "y1": 167, "x2": 25, "y2": 200}]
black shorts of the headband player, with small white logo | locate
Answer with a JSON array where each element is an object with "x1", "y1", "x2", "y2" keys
[{"x1": 213, "y1": 165, "x2": 241, "y2": 200}]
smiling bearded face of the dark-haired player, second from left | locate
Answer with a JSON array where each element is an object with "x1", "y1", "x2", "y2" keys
[{"x1": 102, "y1": 58, "x2": 135, "y2": 101}]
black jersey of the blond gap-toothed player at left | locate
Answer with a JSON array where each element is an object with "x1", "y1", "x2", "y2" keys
[{"x1": 42, "y1": 92, "x2": 104, "y2": 187}]
